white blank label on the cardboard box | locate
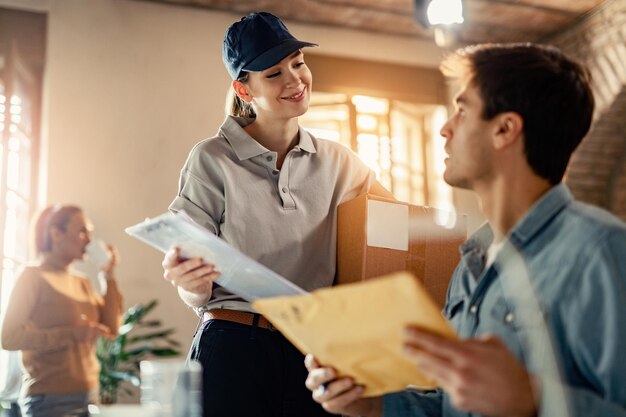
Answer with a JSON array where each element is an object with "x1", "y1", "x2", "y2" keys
[{"x1": 367, "y1": 200, "x2": 409, "y2": 251}]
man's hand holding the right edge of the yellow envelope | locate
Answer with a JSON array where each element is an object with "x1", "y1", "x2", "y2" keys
[{"x1": 404, "y1": 327, "x2": 538, "y2": 417}]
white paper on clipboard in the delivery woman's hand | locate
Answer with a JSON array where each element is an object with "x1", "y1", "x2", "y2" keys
[{"x1": 126, "y1": 212, "x2": 306, "y2": 302}]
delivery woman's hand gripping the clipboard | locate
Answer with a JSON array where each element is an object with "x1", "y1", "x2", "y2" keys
[{"x1": 162, "y1": 247, "x2": 220, "y2": 294}]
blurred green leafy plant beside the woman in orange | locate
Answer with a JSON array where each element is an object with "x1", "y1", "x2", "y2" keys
[{"x1": 96, "y1": 300, "x2": 181, "y2": 404}]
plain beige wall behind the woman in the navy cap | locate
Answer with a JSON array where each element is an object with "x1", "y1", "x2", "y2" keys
[{"x1": 0, "y1": 0, "x2": 480, "y2": 349}]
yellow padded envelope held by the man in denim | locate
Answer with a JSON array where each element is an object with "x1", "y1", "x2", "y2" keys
[{"x1": 253, "y1": 272, "x2": 456, "y2": 396}]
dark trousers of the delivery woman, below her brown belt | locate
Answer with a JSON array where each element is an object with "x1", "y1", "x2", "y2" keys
[{"x1": 190, "y1": 320, "x2": 330, "y2": 417}]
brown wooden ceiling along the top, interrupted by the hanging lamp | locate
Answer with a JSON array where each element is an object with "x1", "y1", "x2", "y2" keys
[{"x1": 128, "y1": 0, "x2": 604, "y2": 43}]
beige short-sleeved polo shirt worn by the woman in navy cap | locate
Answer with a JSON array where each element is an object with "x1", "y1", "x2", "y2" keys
[{"x1": 169, "y1": 116, "x2": 375, "y2": 311}]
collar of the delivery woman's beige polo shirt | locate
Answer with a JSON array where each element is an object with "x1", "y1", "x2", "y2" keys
[{"x1": 219, "y1": 116, "x2": 317, "y2": 161}]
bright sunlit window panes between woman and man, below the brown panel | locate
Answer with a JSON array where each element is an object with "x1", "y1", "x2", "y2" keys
[{"x1": 300, "y1": 92, "x2": 452, "y2": 209}]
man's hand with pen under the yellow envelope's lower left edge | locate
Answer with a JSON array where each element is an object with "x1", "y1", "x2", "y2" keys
[{"x1": 304, "y1": 354, "x2": 382, "y2": 417}]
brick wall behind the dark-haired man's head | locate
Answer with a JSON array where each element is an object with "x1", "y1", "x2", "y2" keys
[{"x1": 546, "y1": 0, "x2": 626, "y2": 220}]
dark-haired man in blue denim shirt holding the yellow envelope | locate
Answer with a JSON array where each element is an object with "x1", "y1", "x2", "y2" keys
[{"x1": 306, "y1": 44, "x2": 626, "y2": 417}]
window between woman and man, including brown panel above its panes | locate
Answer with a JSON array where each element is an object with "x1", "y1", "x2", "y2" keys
[{"x1": 300, "y1": 52, "x2": 454, "y2": 212}]
